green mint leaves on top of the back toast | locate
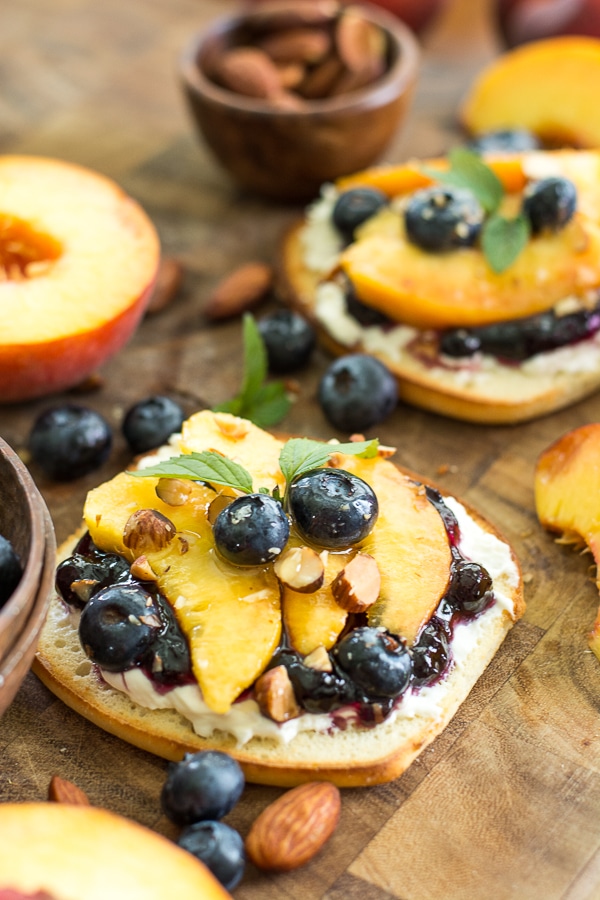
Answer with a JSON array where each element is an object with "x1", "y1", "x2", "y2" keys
[{"x1": 423, "y1": 147, "x2": 531, "y2": 275}]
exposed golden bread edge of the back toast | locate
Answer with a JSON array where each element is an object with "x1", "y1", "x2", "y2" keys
[{"x1": 278, "y1": 220, "x2": 600, "y2": 425}]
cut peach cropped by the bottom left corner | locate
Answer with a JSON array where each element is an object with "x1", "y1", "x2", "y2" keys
[{"x1": 0, "y1": 803, "x2": 231, "y2": 900}]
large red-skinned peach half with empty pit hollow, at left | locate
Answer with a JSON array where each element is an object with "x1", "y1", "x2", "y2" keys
[{"x1": 0, "y1": 156, "x2": 160, "y2": 402}]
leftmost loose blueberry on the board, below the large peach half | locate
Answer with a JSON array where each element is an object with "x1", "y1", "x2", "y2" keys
[{"x1": 29, "y1": 404, "x2": 112, "y2": 481}]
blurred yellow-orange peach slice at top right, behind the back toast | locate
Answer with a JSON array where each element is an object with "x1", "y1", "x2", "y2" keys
[{"x1": 459, "y1": 35, "x2": 600, "y2": 148}]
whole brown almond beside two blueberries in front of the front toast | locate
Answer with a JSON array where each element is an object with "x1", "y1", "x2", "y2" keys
[{"x1": 246, "y1": 781, "x2": 341, "y2": 872}]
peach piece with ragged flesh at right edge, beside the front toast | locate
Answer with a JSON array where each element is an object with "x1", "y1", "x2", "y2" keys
[{"x1": 534, "y1": 423, "x2": 600, "y2": 659}]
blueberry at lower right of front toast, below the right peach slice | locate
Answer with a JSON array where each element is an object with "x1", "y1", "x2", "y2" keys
[{"x1": 332, "y1": 627, "x2": 411, "y2": 698}]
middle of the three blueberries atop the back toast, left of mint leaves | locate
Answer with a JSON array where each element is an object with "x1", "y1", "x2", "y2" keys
[{"x1": 404, "y1": 185, "x2": 485, "y2": 252}]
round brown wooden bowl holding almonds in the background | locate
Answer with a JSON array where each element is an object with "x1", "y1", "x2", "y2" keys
[{"x1": 180, "y1": 0, "x2": 420, "y2": 202}]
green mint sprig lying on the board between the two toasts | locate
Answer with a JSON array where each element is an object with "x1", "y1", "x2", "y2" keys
[{"x1": 213, "y1": 313, "x2": 291, "y2": 428}]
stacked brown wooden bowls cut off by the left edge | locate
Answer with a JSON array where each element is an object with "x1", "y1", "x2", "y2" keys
[{"x1": 0, "y1": 438, "x2": 56, "y2": 714}]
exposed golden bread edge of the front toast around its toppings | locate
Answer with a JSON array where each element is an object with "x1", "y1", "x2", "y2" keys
[{"x1": 34, "y1": 467, "x2": 525, "y2": 787}]
